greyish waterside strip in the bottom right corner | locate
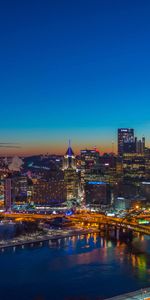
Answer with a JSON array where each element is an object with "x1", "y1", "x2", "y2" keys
[{"x1": 105, "y1": 288, "x2": 150, "y2": 300}]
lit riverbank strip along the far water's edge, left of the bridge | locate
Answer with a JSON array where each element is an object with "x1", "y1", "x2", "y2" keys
[{"x1": 0, "y1": 229, "x2": 100, "y2": 249}]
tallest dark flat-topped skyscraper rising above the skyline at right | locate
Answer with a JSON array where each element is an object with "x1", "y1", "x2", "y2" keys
[{"x1": 118, "y1": 128, "x2": 136, "y2": 156}]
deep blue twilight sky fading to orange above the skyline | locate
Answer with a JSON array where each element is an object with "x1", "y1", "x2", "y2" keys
[{"x1": 0, "y1": 0, "x2": 150, "y2": 154}]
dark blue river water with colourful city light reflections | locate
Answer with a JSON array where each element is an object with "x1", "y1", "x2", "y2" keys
[{"x1": 0, "y1": 235, "x2": 150, "y2": 300}]
